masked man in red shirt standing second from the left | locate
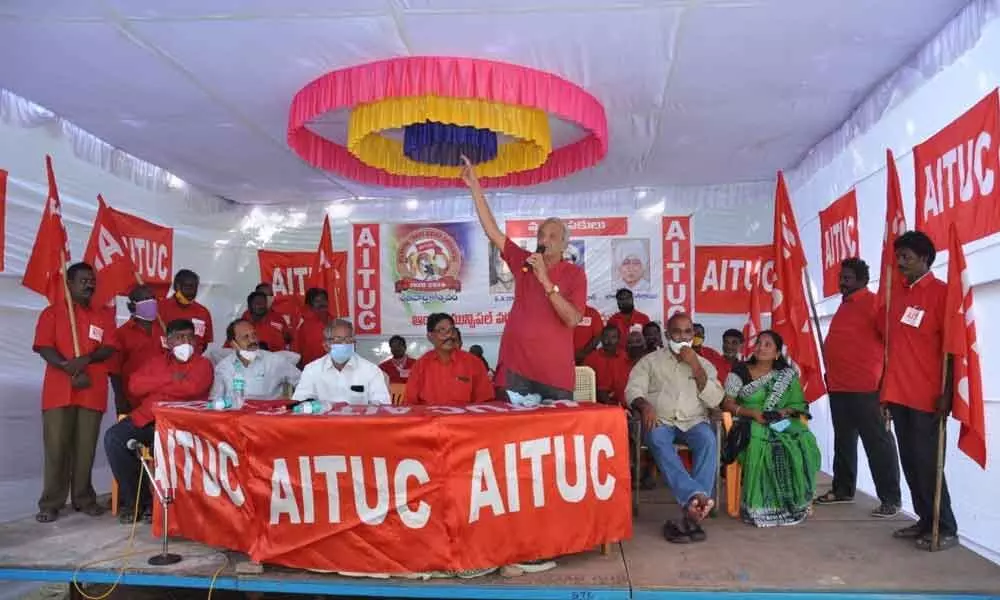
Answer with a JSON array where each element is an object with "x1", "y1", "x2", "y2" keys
[{"x1": 110, "y1": 285, "x2": 167, "y2": 415}]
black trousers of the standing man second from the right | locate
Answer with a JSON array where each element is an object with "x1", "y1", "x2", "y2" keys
[{"x1": 830, "y1": 392, "x2": 902, "y2": 506}]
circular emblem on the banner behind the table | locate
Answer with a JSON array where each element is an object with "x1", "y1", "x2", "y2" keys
[{"x1": 396, "y1": 227, "x2": 462, "y2": 293}]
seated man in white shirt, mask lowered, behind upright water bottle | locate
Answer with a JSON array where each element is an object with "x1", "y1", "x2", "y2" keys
[{"x1": 209, "y1": 319, "x2": 302, "y2": 408}]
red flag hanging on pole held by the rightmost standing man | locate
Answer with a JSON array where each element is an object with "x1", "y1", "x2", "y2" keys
[{"x1": 944, "y1": 223, "x2": 986, "y2": 469}]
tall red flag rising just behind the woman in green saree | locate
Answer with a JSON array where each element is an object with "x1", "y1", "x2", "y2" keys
[{"x1": 771, "y1": 171, "x2": 826, "y2": 402}]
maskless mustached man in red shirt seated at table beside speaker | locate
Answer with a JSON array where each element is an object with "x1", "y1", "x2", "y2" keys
[{"x1": 406, "y1": 313, "x2": 493, "y2": 406}]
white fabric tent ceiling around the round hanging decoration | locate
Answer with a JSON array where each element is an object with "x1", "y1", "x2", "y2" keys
[{"x1": 0, "y1": 0, "x2": 967, "y2": 203}]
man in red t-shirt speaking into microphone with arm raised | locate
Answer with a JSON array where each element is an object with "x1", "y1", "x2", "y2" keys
[{"x1": 462, "y1": 160, "x2": 587, "y2": 408}]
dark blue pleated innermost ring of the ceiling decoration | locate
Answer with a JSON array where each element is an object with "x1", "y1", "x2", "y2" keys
[{"x1": 403, "y1": 121, "x2": 497, "y2": 167}]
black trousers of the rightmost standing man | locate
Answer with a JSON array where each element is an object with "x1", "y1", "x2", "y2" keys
[{"x1": 889, "y1": 404, "x2": 958, "y2": 535}]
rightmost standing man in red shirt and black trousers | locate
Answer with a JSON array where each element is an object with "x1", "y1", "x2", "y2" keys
[{"x1": 876, "y1": 231, "x2": 958, "y2": 550}]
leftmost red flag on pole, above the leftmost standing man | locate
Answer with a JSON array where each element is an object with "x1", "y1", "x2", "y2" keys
[{"x1": 21, "y1": 155, "x2": 71, "y2": 304}]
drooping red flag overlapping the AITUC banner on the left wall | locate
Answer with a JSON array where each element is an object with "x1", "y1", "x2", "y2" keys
[{"x1": 83, "y1": 195, "x2": 138, "y2": 306}]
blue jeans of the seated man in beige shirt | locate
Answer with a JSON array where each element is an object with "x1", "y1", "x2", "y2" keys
[{"x1": 646, "y1": 423, "x2": 719, "y2": 508}]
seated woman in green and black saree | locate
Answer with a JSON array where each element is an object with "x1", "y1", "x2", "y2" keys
[{"x1": 723, "y1": 330, "x2": 820, "y2": 527}]
